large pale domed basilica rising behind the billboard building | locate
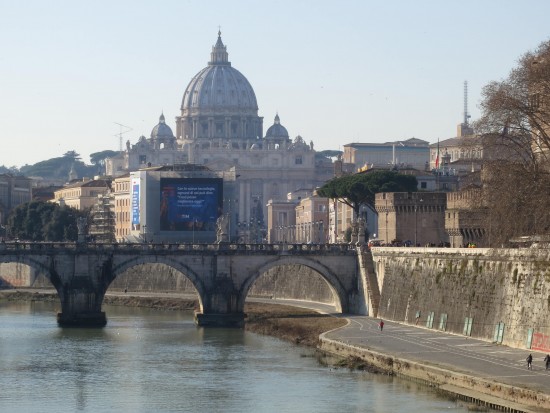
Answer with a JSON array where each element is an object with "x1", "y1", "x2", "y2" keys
[{"x1": 106, "y1": 32, "x2": 334, "y2": 232}]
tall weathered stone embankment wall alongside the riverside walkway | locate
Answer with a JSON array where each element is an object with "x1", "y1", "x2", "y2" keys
[{"x1": 373, "y1": 248, "x2": 550, "y2": 351}]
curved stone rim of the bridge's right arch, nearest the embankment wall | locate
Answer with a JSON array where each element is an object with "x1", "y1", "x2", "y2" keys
[{"x1": 238, "y1": 256, "x2": 348, "y2": 312}]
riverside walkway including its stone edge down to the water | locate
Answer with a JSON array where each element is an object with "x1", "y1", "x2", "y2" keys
[{"x1": 321, "y1": 314, "x2": 550, "y2": 412}]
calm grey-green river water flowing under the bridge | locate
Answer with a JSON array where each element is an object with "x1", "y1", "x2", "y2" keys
[{"x1": 0, "y1": 301, "x2": 490, "y2": 413}]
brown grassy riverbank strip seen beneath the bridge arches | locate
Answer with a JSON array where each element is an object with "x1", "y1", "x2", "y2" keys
[{"x1": 0, "y1": 290, "x2": 346, "y2": 347}]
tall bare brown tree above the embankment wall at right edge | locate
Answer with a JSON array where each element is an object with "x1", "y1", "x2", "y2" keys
[{"x1": 475, "y1": 41, "x2": 550, "y2": 246}]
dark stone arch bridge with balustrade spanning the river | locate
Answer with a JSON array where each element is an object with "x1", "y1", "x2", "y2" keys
[{"x1": 0, "y1": 242, "x2": 379, "y2": 326}]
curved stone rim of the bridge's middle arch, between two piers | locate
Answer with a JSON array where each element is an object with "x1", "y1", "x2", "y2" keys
[{"x1": 111, "y1": 256, "x2": 205, "y2": 312}]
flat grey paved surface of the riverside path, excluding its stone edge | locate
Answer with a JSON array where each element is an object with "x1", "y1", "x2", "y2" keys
[{"x1": 327, "y1": 315, "x2": 550, "y2": 392}]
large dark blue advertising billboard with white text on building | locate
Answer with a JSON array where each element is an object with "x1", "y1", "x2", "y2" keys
[{"x1": 160, "y1": 178, "x2": 223, "y2": 231}]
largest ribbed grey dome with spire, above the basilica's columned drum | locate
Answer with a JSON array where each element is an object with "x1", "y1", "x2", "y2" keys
[{"x1": 181, "y1": 32, "x2": 258, "y2": 116}]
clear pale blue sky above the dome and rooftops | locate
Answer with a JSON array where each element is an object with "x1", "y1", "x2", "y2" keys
[{"x1": 0, "y1": 0, "x2": 550, "y2": 166}]
